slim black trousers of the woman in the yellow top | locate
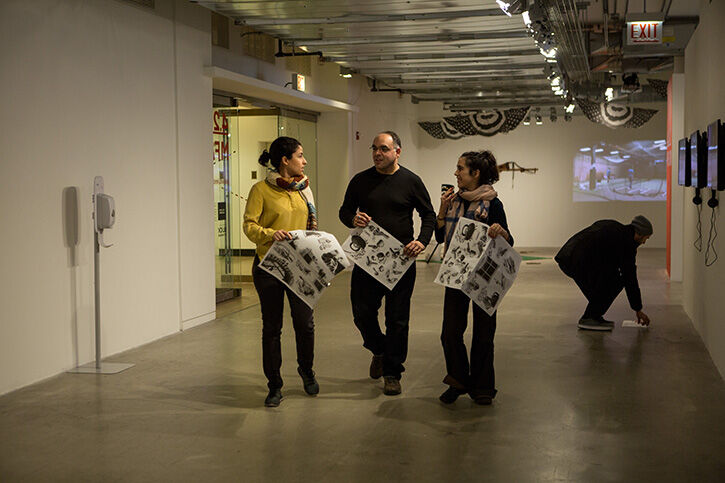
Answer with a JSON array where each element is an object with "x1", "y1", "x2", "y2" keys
[{"x1": 252, "y1": 256, "x2": 315, "y2": 389}]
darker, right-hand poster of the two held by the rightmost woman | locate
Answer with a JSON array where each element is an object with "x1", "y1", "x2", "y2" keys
[{"x1": 461, "y1": 237, "x2": 521, "y2": 315}]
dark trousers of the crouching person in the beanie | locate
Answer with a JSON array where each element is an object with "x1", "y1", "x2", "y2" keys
[{"x1": 559, "y1": 264, "x2": 624, "y2": 319}]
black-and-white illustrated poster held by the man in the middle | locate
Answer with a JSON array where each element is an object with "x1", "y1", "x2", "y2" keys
[{"x1": 342, "y1": 221, "x2": 415, "y2": 290}]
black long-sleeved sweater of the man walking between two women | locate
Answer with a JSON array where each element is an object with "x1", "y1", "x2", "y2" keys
[{"x1": 339, "y1": 166, "x2": 436, "y2": 245}]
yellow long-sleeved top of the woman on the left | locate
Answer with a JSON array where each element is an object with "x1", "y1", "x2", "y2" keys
[{"x1": 243, "y1": 181, "x2": 308, "y2": 259}]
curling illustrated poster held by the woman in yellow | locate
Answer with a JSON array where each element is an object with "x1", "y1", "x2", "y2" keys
[{"x1": 259, "y1": 230, "x2": 350, "y2": 308}]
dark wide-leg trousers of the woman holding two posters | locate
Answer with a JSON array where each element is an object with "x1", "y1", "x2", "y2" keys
[{"x1": 441, "y1": 287, "x2": 497, "y2": 397}]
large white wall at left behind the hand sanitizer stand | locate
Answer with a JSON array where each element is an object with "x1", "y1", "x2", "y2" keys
[{"x1": 0, "y1": 0, "x2": 214, "y2": 393}]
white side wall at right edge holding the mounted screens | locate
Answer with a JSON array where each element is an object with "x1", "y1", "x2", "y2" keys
[{"x1": 683, "y1": 1, "x2": 725, "y2": 377}]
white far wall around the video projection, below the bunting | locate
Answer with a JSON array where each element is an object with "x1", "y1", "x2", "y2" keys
[{"x1": 410, "y1": 103, "x2": 667, "y2": 247}]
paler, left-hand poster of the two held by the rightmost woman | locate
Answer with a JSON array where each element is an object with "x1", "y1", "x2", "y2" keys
[{"x1": 435, "y1": 218, "x2": 488, "y2": 289}]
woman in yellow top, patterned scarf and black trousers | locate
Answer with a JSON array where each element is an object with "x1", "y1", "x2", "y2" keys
[{"x1": 244, "y1": 136, "x2": 320, "y2": 407}]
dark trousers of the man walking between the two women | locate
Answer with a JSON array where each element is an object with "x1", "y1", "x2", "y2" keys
[{"x1": 350, "y1": 263, "x2": 415, "y2": 379}]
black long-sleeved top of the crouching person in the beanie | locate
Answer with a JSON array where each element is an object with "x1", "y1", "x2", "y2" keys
[{"x1": 554, "y1": 220, "x2": 642, "y2": 310}]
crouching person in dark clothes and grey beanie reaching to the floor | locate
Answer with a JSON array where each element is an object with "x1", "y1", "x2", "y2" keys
[{"x1": 554, "y1": 215, "x2": 652, "y2": 330}]
